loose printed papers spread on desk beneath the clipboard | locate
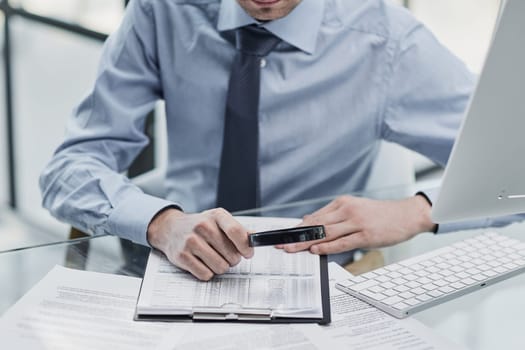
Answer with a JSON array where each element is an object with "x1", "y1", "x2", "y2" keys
[{"x1": 0, "y1": 216, "x2": 466, "y2": 350}]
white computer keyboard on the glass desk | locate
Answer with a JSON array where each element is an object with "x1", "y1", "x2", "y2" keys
[{"x1": 336, "y1": 232, "x2": 525, "y2": 318}]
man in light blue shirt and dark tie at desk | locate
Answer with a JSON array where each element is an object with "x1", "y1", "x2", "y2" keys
[{"x1": 41, "y1": 0, "x2": 474, "y2": 280}]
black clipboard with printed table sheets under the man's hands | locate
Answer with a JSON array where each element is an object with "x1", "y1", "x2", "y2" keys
[{"x1": 136, "y1": 217, "x2": 330, "y2": 323}]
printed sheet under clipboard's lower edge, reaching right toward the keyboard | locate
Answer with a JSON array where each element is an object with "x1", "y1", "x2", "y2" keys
[{"x1": 158, "y1": 263, "x2": 459, "y2": 350}]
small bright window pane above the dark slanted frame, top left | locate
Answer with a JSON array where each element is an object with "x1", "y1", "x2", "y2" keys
[{"x1": 10, "y1": 0, "x2": 124, "y2": 33}]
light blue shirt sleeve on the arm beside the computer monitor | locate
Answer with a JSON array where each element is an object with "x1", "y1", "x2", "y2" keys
[{"x1": 381, "y1": 22, "x2": 476, "y2": 166}]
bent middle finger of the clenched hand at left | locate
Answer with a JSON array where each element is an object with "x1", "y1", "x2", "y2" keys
[{"x1": 194, "y1": 219, "x2": 241, "y2": 266}]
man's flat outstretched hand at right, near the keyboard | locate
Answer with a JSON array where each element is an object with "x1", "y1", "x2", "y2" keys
[{"x1": 277, "y1": 195, "x2": 435, "y2": 254}]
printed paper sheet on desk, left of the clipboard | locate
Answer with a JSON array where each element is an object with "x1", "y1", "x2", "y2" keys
[{"x1": 0, "y1": 266, "x2": 175, "y2": 350}]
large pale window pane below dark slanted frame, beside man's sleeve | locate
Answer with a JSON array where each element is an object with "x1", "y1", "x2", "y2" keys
[{"x1": 10, "y1": 17, "x2": 102, "y2": 235}]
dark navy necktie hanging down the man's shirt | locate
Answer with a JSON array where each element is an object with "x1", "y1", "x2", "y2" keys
[{"x1": 217, "y1": 25, "x2": 280, "y2": 211}]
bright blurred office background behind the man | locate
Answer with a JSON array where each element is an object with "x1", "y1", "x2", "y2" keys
[{"x1": 0, "y1": 0, "x2": 500, "y2": 246}]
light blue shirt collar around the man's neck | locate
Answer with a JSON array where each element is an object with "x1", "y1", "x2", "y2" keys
[{"x1": 217, "y1": 0, "x2": 325, "y2": 54}]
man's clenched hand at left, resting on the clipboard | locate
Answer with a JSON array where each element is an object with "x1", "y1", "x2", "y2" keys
[{"x1": 148, "y1": 208, "x2": 253, "y2": 281}]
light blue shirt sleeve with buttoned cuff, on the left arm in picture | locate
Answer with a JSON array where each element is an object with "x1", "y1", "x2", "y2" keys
[{"x1": 40, "y1": 0, "x2": 174, "y2": 245}]
